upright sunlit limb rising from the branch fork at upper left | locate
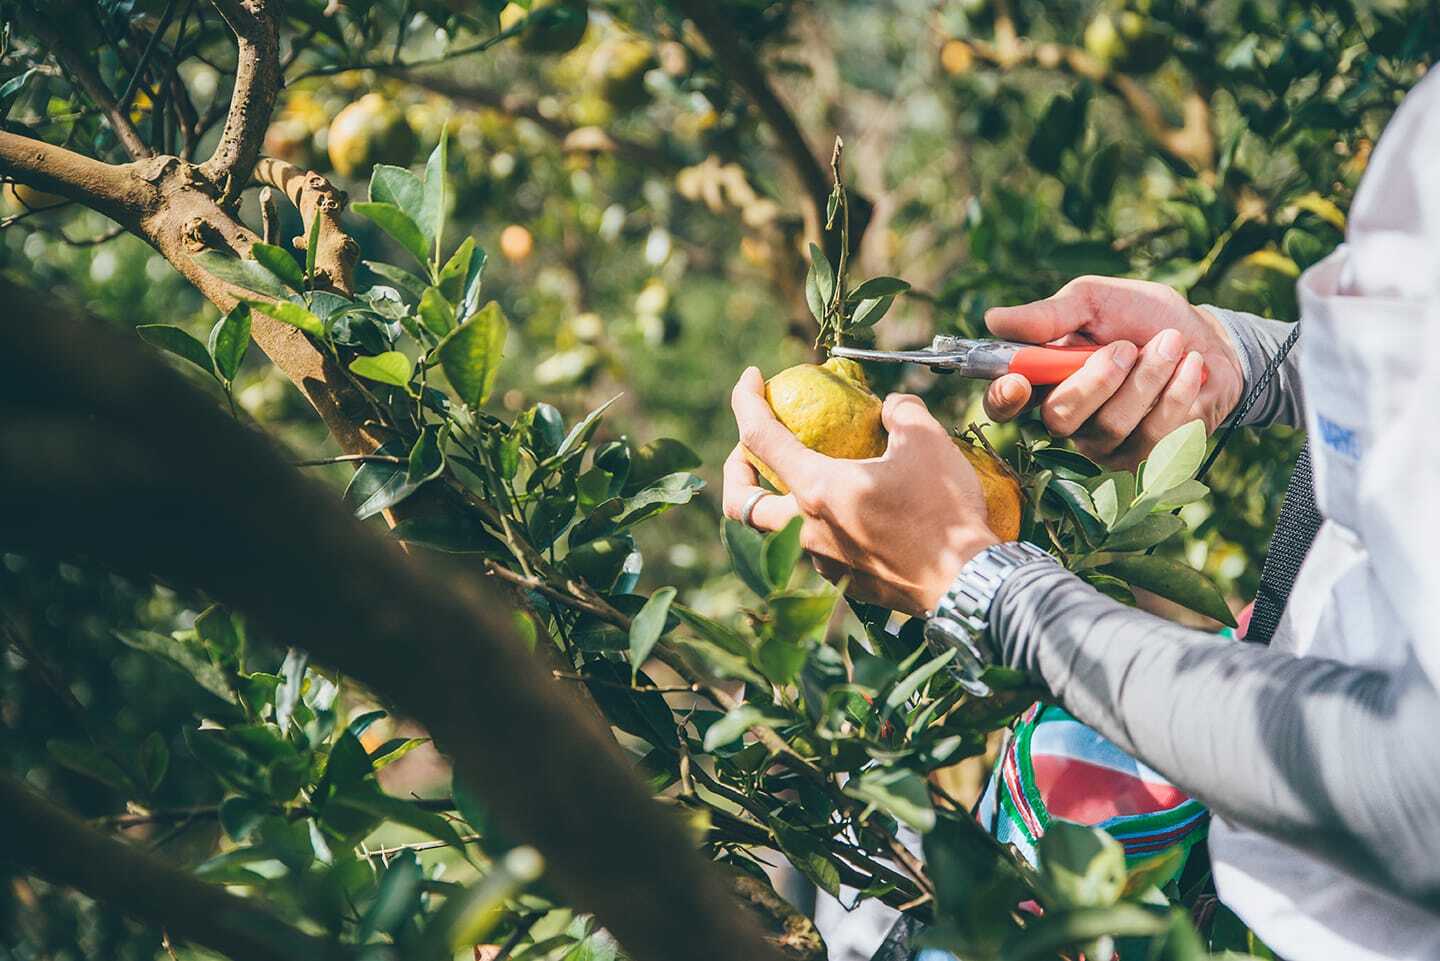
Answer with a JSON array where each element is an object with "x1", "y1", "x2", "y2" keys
[{"x1": 200, "y1": 0, "x2": 281, "y2": 202}]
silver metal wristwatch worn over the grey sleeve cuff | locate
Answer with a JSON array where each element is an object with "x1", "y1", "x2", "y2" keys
[{"x1": 924, "y1": 540, "x2": 1054, "y2": 697}]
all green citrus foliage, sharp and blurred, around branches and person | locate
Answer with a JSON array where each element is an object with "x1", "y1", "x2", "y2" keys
[{"x1": 0, "y1": 0, "x2": 1437, "y2": 960}]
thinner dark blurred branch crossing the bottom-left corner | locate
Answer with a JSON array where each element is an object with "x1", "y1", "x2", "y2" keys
[{"x1": 0, "y1": 777, "x2": 340, "y2": 961}]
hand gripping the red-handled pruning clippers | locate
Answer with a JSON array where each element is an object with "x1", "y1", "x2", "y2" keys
[{"x1": 985, "y1": 277, "x2": 1244, "y2": 468}]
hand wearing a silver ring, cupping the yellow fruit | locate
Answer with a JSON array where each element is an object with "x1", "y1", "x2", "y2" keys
[{"x1": 724, "y1": 367, "x2": 998, "y2": 615}]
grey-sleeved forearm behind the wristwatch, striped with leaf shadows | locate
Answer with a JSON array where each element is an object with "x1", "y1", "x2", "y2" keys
[{"x1": 991, "y1": 562, "x2": 1440, "y2": 908}]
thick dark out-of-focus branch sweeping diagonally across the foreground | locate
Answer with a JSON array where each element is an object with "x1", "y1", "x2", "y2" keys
[{"x1": 0, "y1": 281, "x2": 778, "y2": 961}]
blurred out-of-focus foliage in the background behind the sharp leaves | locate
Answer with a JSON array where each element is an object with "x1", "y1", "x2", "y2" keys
[{"x1": 0, "y1": 0, "x2": 1440, "y2": 960}]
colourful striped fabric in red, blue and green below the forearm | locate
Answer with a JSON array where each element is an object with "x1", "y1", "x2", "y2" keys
[{"x1": 976, "y1": 703, "x2": 1208, "y2": 870}]
